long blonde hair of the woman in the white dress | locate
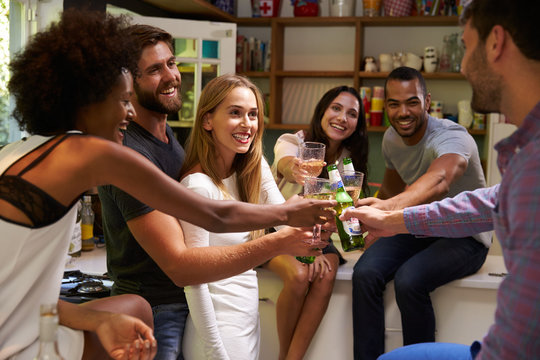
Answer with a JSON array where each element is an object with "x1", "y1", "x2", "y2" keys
[{"x1": 181, "y1": 74, "x2": 264, "y2": 238}]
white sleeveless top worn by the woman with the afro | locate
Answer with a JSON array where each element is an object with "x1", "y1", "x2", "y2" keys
[{"x1": 0, "y1": 135, "x2": 84, "y2": 360}]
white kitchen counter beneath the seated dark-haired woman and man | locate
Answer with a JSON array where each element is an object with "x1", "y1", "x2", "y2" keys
[{"x1": 257, "y1": 241, "x2": 506, "y2": 360}]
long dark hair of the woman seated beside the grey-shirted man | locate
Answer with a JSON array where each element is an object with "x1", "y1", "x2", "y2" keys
[{"x1": 305, "y1": 85, "x2": 369, "y2": 195}]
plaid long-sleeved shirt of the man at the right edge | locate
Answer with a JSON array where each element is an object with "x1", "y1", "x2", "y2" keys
[{"x1": 404, "y1": 103, "x2": 540, "y2": 360}]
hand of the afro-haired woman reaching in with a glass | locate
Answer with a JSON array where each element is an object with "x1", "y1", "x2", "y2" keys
[{"x1": 285, "y1": 195, "x2": 337, "y2": 226}]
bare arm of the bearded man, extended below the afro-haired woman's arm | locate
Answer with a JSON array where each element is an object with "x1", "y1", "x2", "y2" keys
[{"x1": 128, "y1": 210, "x2": 320, "y2": 287}]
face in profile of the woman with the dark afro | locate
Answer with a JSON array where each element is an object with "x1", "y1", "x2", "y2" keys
[{"x1": 77, "y1": 72, "x2": 135, "y2": 144}]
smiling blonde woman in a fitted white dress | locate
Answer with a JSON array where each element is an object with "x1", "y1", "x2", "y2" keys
[{"x1": 181, "y1": 75, "x2": 312, "y2": 360}]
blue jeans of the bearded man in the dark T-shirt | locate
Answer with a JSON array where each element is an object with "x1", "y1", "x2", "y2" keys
[{"x1": 152, "y1": 303, "x2": 189, "y2": 360}]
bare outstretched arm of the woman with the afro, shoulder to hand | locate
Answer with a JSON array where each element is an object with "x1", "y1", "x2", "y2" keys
[{"x1": 64, "y1": 137, "x2": 335, "y2": 232}]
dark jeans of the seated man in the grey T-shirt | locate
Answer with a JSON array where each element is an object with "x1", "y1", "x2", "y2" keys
[{"x1": 353, "y1": 234, "x2": 488, "y2": 360}]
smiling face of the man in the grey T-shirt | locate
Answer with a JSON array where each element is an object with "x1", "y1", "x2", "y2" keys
[{"x1": 385, "y1": 78, "x2": 431, "y2": 145}]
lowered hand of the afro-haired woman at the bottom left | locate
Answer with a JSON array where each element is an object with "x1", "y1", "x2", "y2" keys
[{"x1": 96, "y1": 314, "x2": 157, "y2": 360}]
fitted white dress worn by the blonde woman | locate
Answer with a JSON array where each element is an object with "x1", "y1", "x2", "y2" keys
[{"x1": 181, "y1": 159, "x2": 284, "y2": 360}]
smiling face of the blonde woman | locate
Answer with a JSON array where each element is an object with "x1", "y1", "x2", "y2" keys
[{"x1": 203, "y1": 87, "x2": 259, "y2": 166}]
